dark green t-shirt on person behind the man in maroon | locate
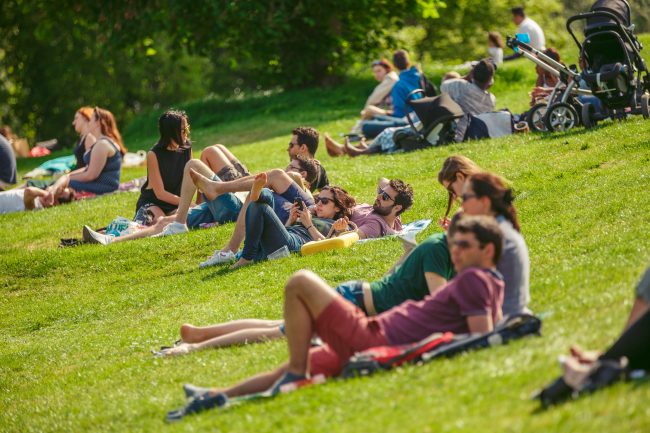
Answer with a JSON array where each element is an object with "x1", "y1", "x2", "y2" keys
[{"x1": 370, "y1": 233, "x2": 455, "y2": 313}]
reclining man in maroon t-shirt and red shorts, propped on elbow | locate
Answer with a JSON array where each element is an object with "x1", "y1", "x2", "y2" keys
[{"x1": 170, "y1": 216, "x2": 503, "y2": 414}]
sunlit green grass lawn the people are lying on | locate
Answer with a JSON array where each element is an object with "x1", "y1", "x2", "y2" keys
[{"x1": 0, "y1": 38, "x2": 650, "y2": 432}]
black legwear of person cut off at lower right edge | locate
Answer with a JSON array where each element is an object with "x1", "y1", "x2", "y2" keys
[{"x1": 600, "y1": 310, "x2": 650, "y2": 371}]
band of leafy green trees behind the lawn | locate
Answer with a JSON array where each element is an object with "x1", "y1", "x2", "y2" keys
[{"x1": 0, "y1": 0, "x2": 650, "y2": 145}]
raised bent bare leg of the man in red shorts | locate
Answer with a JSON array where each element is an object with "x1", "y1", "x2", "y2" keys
[{"x1": 284, "y1": 270, "x2": 338, "y2": 376}]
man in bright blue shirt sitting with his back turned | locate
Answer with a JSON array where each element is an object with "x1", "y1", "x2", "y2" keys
[{"x1": 361, "y1": 50, "x2": 422, "y2": 138}]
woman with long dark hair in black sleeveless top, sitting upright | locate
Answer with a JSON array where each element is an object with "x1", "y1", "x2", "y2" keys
[{"x1": 134, "y1": 110, "x2": 192, "y2": 225}]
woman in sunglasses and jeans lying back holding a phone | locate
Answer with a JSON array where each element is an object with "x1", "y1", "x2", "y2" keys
[{"x1": 233, "y1": 173, "x2": 356, "y2": 268}]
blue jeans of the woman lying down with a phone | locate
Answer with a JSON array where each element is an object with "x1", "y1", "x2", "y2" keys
[{"x1": 242, "y1": 188, "x2": 305, "y2": 260}]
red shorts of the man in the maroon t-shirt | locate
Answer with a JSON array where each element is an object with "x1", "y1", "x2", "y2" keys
[{"x1": 309, "y1": 296, "x2": 388, "y2": 376}]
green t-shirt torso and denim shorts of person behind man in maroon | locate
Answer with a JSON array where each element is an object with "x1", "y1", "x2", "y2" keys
[{"x1": 336, "y1": 233, "x2": 455, "y2": 315}]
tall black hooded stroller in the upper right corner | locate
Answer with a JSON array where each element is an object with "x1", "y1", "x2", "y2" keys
[{"x1": 567, "y1": 0, "x2": 650, "y2": 128}]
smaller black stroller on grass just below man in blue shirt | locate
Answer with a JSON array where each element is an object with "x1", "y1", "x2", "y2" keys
[{"x1": 393, "y1": 89, "x2": 464, "y2": 152}]
